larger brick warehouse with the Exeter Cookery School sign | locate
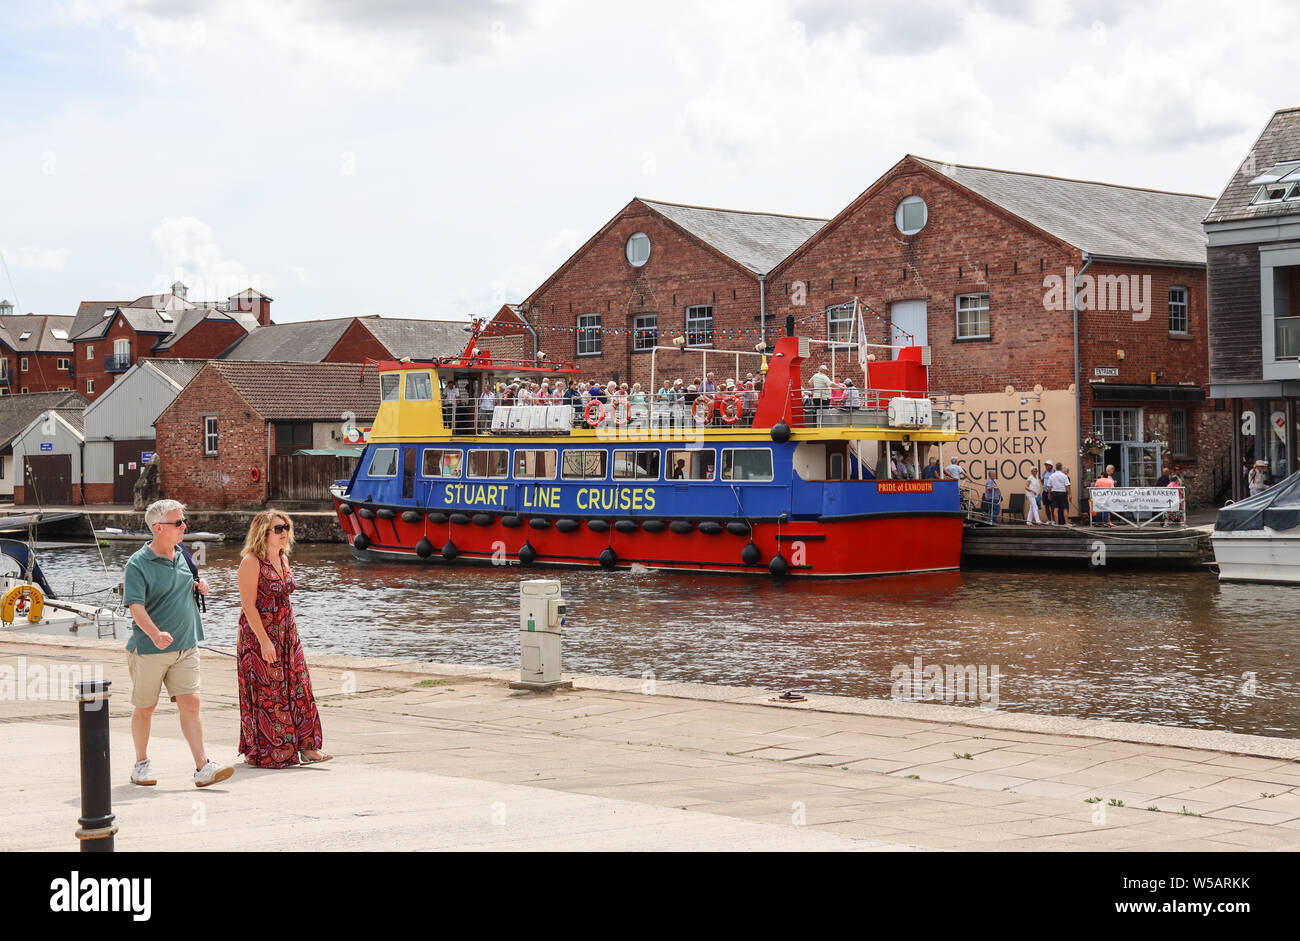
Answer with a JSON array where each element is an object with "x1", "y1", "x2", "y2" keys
[{"x1": 767, "y1": 155, "x2": 1231, "y2": 503}]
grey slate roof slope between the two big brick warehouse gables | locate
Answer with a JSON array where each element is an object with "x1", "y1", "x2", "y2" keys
[{"x1": 641, "y1": 199, "x2": 827, "y2": 274}]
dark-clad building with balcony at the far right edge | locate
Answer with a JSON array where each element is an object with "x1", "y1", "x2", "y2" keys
[{"x1": 1205, "y1": 108, "x2": 1300, "y2": 499}]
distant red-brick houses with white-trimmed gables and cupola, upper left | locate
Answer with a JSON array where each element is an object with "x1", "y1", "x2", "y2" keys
[{"x1": 69, "y1": 282, "x2": 272, "y2": 402}]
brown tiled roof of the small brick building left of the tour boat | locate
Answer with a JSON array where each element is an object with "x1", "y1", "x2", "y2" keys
[{"x1": 207, "y1": 360, "x2": 380, "y2": 421}]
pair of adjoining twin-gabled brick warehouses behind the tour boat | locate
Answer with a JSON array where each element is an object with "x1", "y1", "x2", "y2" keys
[{"x1": 491, "y1": 156, "x2": 1231, "y2": 503}]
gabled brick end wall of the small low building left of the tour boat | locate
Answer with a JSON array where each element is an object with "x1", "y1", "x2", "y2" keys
[{"x1": 153, "y1": 367, "x2": 268, "y2": 509}]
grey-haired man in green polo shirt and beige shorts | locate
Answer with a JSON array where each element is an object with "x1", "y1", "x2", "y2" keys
[{"x1": 122, "y1": 500, "x2": 235, "y2": 788}]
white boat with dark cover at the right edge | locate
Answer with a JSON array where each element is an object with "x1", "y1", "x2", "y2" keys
[{"x1": 1212, "y1": 471, "x2": 1300, "y2": 585}]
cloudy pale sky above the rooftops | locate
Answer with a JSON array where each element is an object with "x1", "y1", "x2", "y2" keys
[{"x1": 0, "y1": 0, "x2": 1300, "y2": 321}]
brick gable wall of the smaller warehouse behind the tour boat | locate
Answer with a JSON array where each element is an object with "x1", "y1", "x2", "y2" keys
[{"x1": 517, "y1": 200, "x2": 758, "y2": 385}]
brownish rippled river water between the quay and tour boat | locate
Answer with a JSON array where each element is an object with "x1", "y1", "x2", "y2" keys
[{"x1": 42, "y1": 545, "x2": 1300, "y2": 737}]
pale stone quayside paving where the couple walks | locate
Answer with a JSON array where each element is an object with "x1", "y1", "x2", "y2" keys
[{"x1": 0, "y1": 634, "x2": 1300, "y2": 851}]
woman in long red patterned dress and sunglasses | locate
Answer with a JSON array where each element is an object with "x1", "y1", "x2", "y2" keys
[{"x1": 237, "y1": 509, "x2": 333, "y2": 768}]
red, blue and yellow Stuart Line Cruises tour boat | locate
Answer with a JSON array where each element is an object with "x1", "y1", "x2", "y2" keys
[{"x1": 332, "y1": 337, "x2": 963, "y2": 576}]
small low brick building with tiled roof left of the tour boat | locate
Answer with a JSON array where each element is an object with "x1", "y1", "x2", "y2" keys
[{"x1": 153, "y1": 360, "x2": 380, "y2": 508}]
